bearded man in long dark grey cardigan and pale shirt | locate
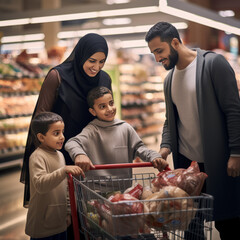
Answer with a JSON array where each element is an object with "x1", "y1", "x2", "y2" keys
[{"x1": 145, "y1": 22, "x2": 240, "y2": 239}]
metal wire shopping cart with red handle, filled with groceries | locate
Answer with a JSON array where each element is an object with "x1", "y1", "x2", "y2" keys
[{"x1": 68, "y1": 162, "x2": 213, "y2": 240}]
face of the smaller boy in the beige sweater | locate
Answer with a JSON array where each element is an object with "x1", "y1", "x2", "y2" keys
[{"x1": 38, "y1": 121, "x2": 65, "y2": 150}]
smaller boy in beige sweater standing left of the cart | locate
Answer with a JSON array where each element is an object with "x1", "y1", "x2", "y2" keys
[{"x1": 26, "y1": 112, "x2": 85, "y2": 240}]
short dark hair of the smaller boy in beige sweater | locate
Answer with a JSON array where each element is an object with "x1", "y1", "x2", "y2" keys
[{"x1": 31, "y1": 112, "x2": 63, "y2": 137}]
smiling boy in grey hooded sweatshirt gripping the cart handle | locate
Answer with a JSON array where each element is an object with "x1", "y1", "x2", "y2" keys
[{"x1": 65, "y1": 87, "x2": 168, "y2": 180}]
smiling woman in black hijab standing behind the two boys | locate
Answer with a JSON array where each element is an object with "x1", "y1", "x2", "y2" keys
[{"x1": 20, "y1": 33, "x2": 111, "y2": 207}]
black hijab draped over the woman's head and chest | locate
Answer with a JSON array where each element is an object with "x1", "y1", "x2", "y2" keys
[{"x1": 55, "y1": 33, "x2": 109, "y2": 123}]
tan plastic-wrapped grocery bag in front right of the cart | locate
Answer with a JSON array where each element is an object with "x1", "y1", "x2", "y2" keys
[{"x1": 144, "y1": 186, "x2": 197, "y2": 230}]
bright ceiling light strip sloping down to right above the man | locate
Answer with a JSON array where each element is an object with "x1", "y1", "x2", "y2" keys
[{"x1": 159, "y1": 0, "x2": 240, "y2": 35}]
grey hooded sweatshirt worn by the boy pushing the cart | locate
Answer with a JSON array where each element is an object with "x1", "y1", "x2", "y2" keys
[{"x1": 65, "y1": 119, "x2": 161, "y2": 180}]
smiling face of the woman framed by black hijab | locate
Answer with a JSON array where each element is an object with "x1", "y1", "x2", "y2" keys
[{"x1": 83, "y1": 52, "x2": 106, "y2": 77}]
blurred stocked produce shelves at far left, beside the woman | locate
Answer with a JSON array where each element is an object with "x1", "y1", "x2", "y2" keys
[{"x1": 0, "y1": 58, "x2": 49, "y2": 162}]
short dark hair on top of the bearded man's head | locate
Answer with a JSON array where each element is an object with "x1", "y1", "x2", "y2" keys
[{"x1": 145, "y1": 22, "x2": 182, "y2": 43}]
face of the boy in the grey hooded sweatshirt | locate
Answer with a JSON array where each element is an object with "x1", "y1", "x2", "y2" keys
[{"x1": 89, "y1": 93, "x2": 116, "y2": 122}]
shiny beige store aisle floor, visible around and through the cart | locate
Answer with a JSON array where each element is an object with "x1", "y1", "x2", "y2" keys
[{"x1": 0, "y1": 154, "x2": 220, "y2": 240}]
